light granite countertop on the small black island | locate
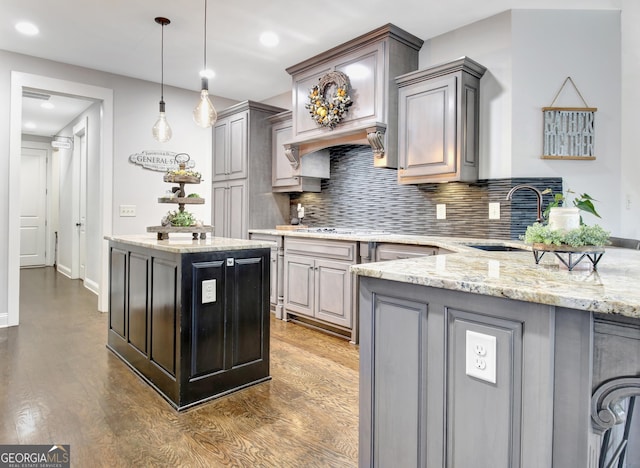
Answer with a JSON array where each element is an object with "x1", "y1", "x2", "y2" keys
[{"x1": 105, "y1": 234, "x2": 271, "y2": 254}]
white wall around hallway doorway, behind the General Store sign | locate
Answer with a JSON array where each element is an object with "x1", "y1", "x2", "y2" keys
[{"x1": 0, "y1": 50, "x2": 236, "y2": 322}]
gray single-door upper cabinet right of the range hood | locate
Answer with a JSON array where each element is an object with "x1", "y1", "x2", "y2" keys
[{"x1": 396, "y1": 57, "x2": 486, "y2": 184}]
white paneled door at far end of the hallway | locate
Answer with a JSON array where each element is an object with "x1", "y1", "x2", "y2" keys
[{"x1": 20, "y1": 147, "x2": 47, "y2": 267}]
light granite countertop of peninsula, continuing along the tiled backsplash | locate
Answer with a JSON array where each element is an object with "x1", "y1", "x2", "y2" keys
[{"x1": 250, "y1": 229, "x2": 640, "y2": 318}]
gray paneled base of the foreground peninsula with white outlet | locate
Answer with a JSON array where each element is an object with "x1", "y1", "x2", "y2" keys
[{"x1": 359, "y1": 277, "x2": 560, "y2": 468}]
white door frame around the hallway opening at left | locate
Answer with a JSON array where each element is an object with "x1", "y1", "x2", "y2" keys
[{"x1": 7, "y1": 71, "x2": 113, "y2": 326}]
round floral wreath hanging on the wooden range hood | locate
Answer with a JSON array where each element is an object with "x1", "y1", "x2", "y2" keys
[{"x1": 305, "y1": 72, "x2": 353, "y2": 130}]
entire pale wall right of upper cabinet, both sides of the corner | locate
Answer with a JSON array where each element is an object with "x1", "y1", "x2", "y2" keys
[{"x1": 420, "y1": 10, "x2": 624, "y2": 236}]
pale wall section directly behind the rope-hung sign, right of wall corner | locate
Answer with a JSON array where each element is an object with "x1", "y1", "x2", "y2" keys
[{"x1": 512, "y1": 10, "x2": 621, "y2": 233}]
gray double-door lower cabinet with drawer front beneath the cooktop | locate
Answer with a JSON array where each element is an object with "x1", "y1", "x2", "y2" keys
[{"x1": 284, "y1": 238, "x2": 357, "y2": 340}]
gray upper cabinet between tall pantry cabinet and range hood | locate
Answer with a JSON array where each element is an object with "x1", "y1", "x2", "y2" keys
[{"x1": 269, "y1": 111, "x2": 329, "y2": 192}]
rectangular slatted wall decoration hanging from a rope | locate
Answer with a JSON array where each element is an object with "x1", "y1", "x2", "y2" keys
[{"x1": 542, "y1": 76, "x2": 598, "y2": 160}]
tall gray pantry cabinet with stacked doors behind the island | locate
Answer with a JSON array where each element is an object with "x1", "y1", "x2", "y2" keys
[{"x1": 211, "y1": 101, "x2": 289, "y2": 239}]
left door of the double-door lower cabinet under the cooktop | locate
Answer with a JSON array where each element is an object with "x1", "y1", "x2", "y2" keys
[{"x1": 284, "y1": 255, "x2": 315, "y2": 317}]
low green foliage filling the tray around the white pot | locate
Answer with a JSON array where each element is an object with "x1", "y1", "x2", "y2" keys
[{"x1": 521, "y1": 223, "x2": 610, "y2": 247}]
